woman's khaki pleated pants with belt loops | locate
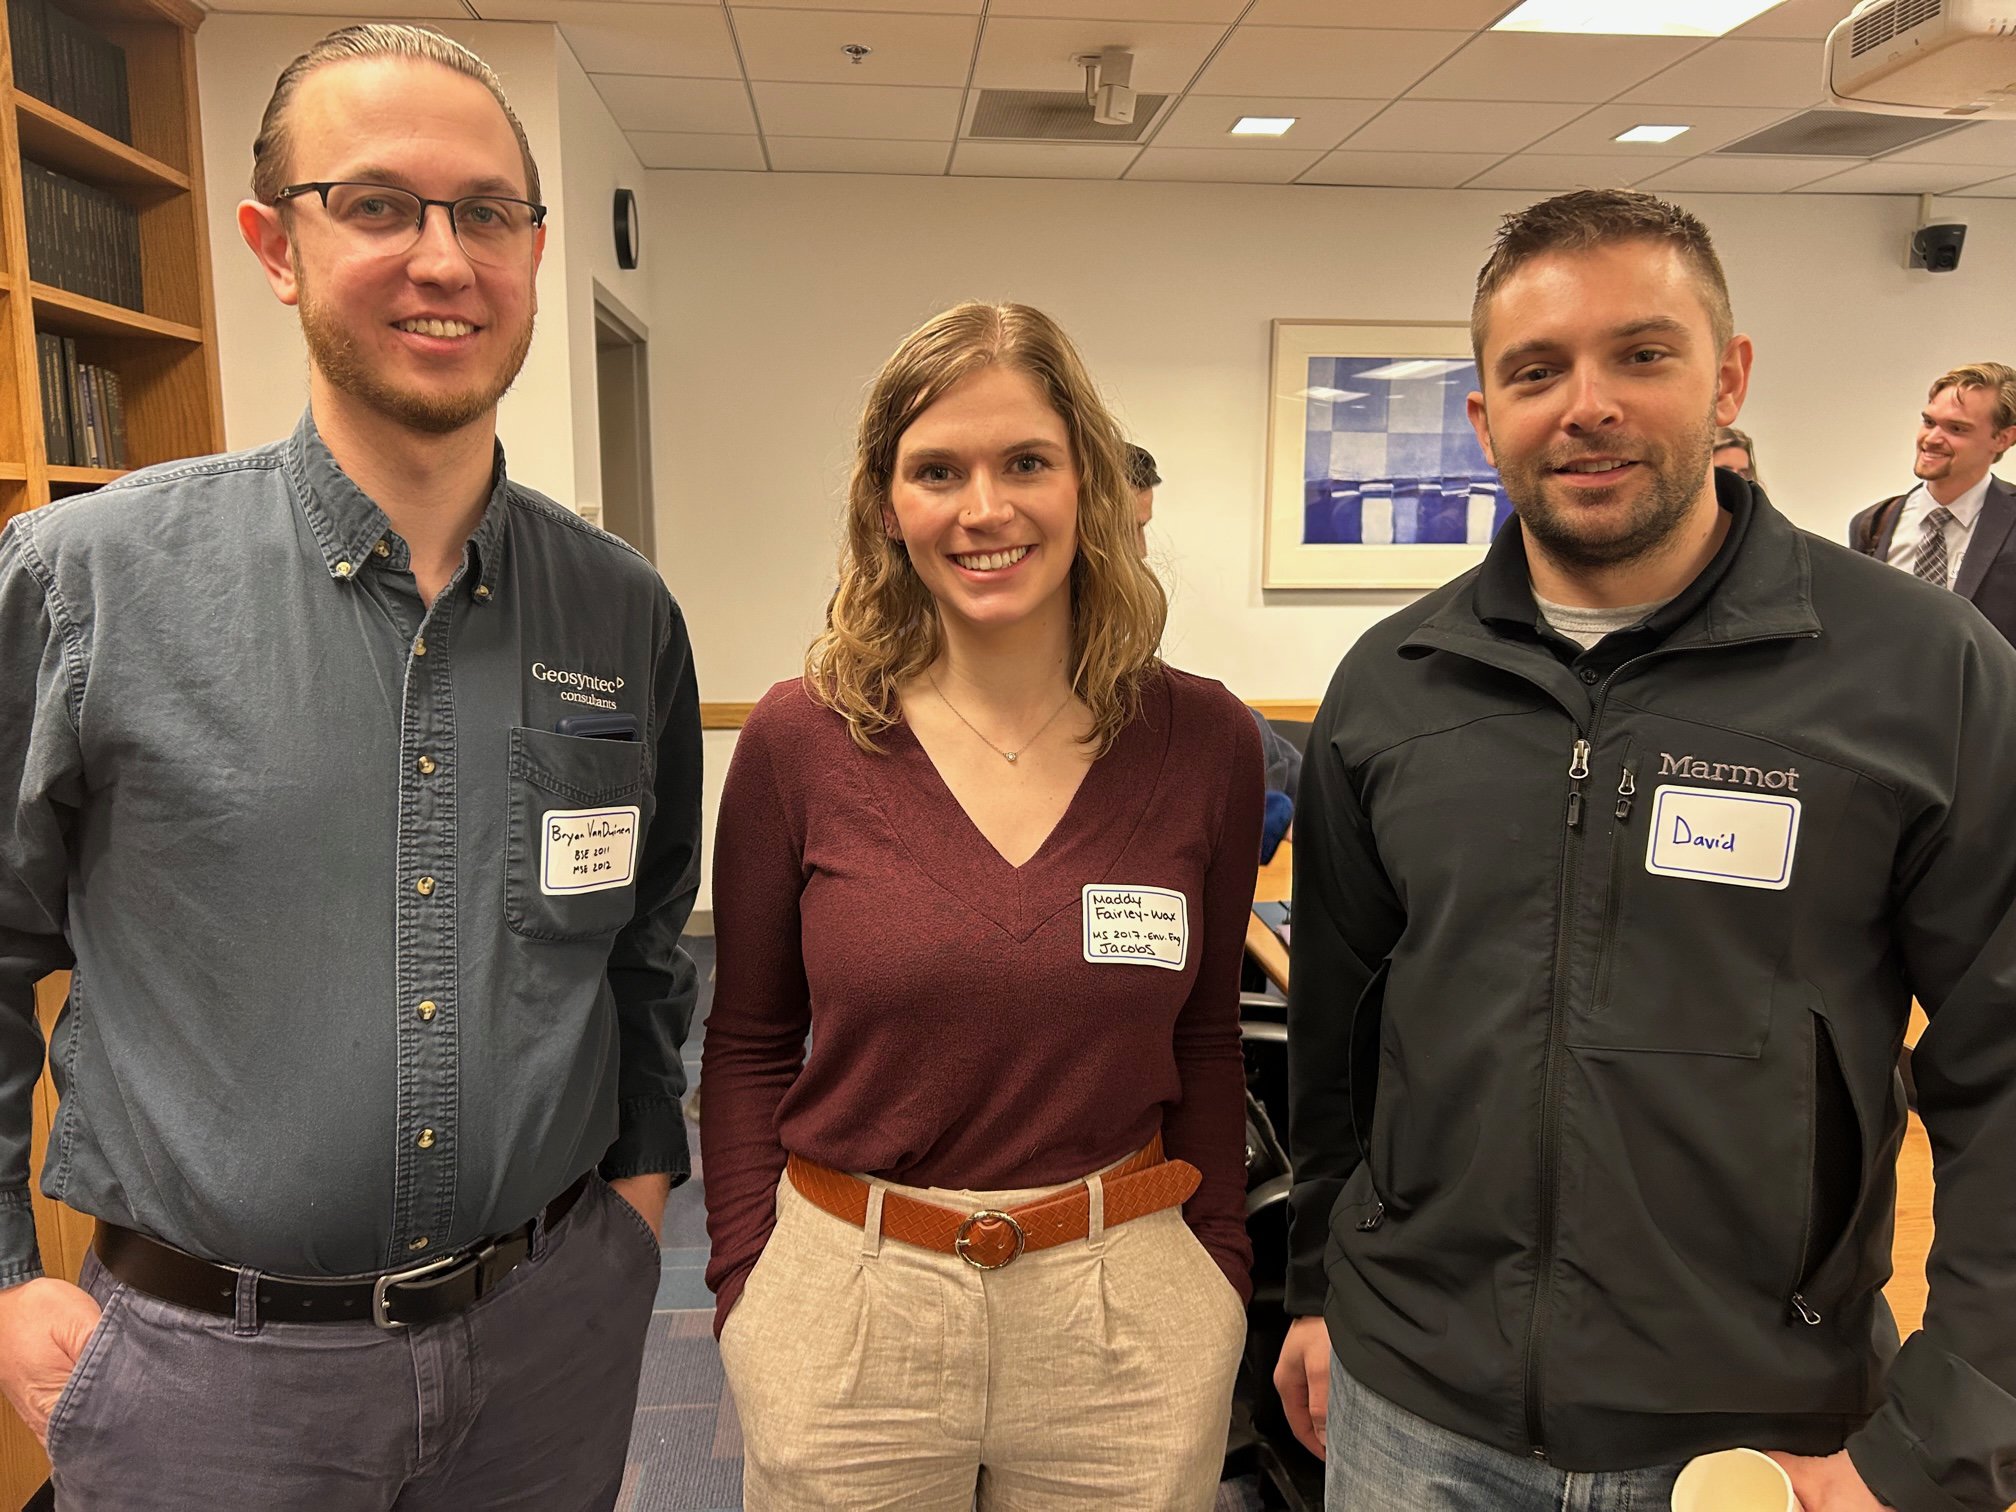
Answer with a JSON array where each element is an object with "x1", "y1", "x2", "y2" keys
[{"x1": 722, "y1": 1153, "x2": 1246, "y2": 1512}]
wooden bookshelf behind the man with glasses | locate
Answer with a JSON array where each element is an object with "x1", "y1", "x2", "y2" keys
[{"x1": 0, "y1": 0, "x2": 224, "y2": 1508}]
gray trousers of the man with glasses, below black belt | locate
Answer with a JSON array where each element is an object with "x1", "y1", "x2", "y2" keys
[{"x1": 48, "y1": 1177, "x2": 659, "y2": 1512}]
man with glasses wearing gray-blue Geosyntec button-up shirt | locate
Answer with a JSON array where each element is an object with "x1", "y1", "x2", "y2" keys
[{"x1": 0, "y1": 26, "x2": 700, "y2": 1512}]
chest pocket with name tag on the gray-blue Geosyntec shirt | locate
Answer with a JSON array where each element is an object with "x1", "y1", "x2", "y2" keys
[{"x1": 504, "y1": 726, "x2": 651, "y2": 939}]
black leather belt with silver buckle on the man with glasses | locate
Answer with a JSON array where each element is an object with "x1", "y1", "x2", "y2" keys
[{"x1": 91, "y1": 1173, "x2": 589, "y2": 1329}]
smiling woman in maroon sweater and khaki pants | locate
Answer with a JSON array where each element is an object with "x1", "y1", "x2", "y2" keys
[{"x1": 702, "y1": 304, "x2": 1262, "y2": 1512}]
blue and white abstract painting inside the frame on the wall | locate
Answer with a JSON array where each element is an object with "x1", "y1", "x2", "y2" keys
[{"x1": 1302, "y1": 357, "x2": 1512, "y2": 546}]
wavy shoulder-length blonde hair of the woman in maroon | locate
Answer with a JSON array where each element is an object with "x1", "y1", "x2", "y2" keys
[{"x1": 804, "y1": 302, "x2": 1169, "y2": 756}]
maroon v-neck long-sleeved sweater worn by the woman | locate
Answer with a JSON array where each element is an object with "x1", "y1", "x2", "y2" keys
[{"x1": 700, "y1": 671, "x2": 1262, "y2": 1329}]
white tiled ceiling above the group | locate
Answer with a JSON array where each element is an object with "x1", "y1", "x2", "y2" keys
[{"x1": 212, "y1": 0, "x2": 2016, "y2": 198}]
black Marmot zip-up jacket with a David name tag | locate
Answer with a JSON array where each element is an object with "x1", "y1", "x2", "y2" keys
[{"x1": 1288, "y1": 474, "x2": 2016, "y2": 1512}]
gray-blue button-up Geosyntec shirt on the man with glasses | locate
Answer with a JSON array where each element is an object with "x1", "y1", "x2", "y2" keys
[{"x1": 0, "y1": 417, "x2": 700, "y2": 1284}]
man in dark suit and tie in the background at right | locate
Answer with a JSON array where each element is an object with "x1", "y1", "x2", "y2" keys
[{"x1": 1849, "y1": 363, "x2": 2016, "y2": 641}]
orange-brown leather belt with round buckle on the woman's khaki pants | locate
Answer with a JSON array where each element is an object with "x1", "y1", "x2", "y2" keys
[{"x1": 784, "y1": 1135, "x2": 1204, "y2": 1270}]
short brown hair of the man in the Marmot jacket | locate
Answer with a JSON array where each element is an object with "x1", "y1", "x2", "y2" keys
[{"x1": 1470, "y1": 190, "x2": 1736, "y2": 366}]
